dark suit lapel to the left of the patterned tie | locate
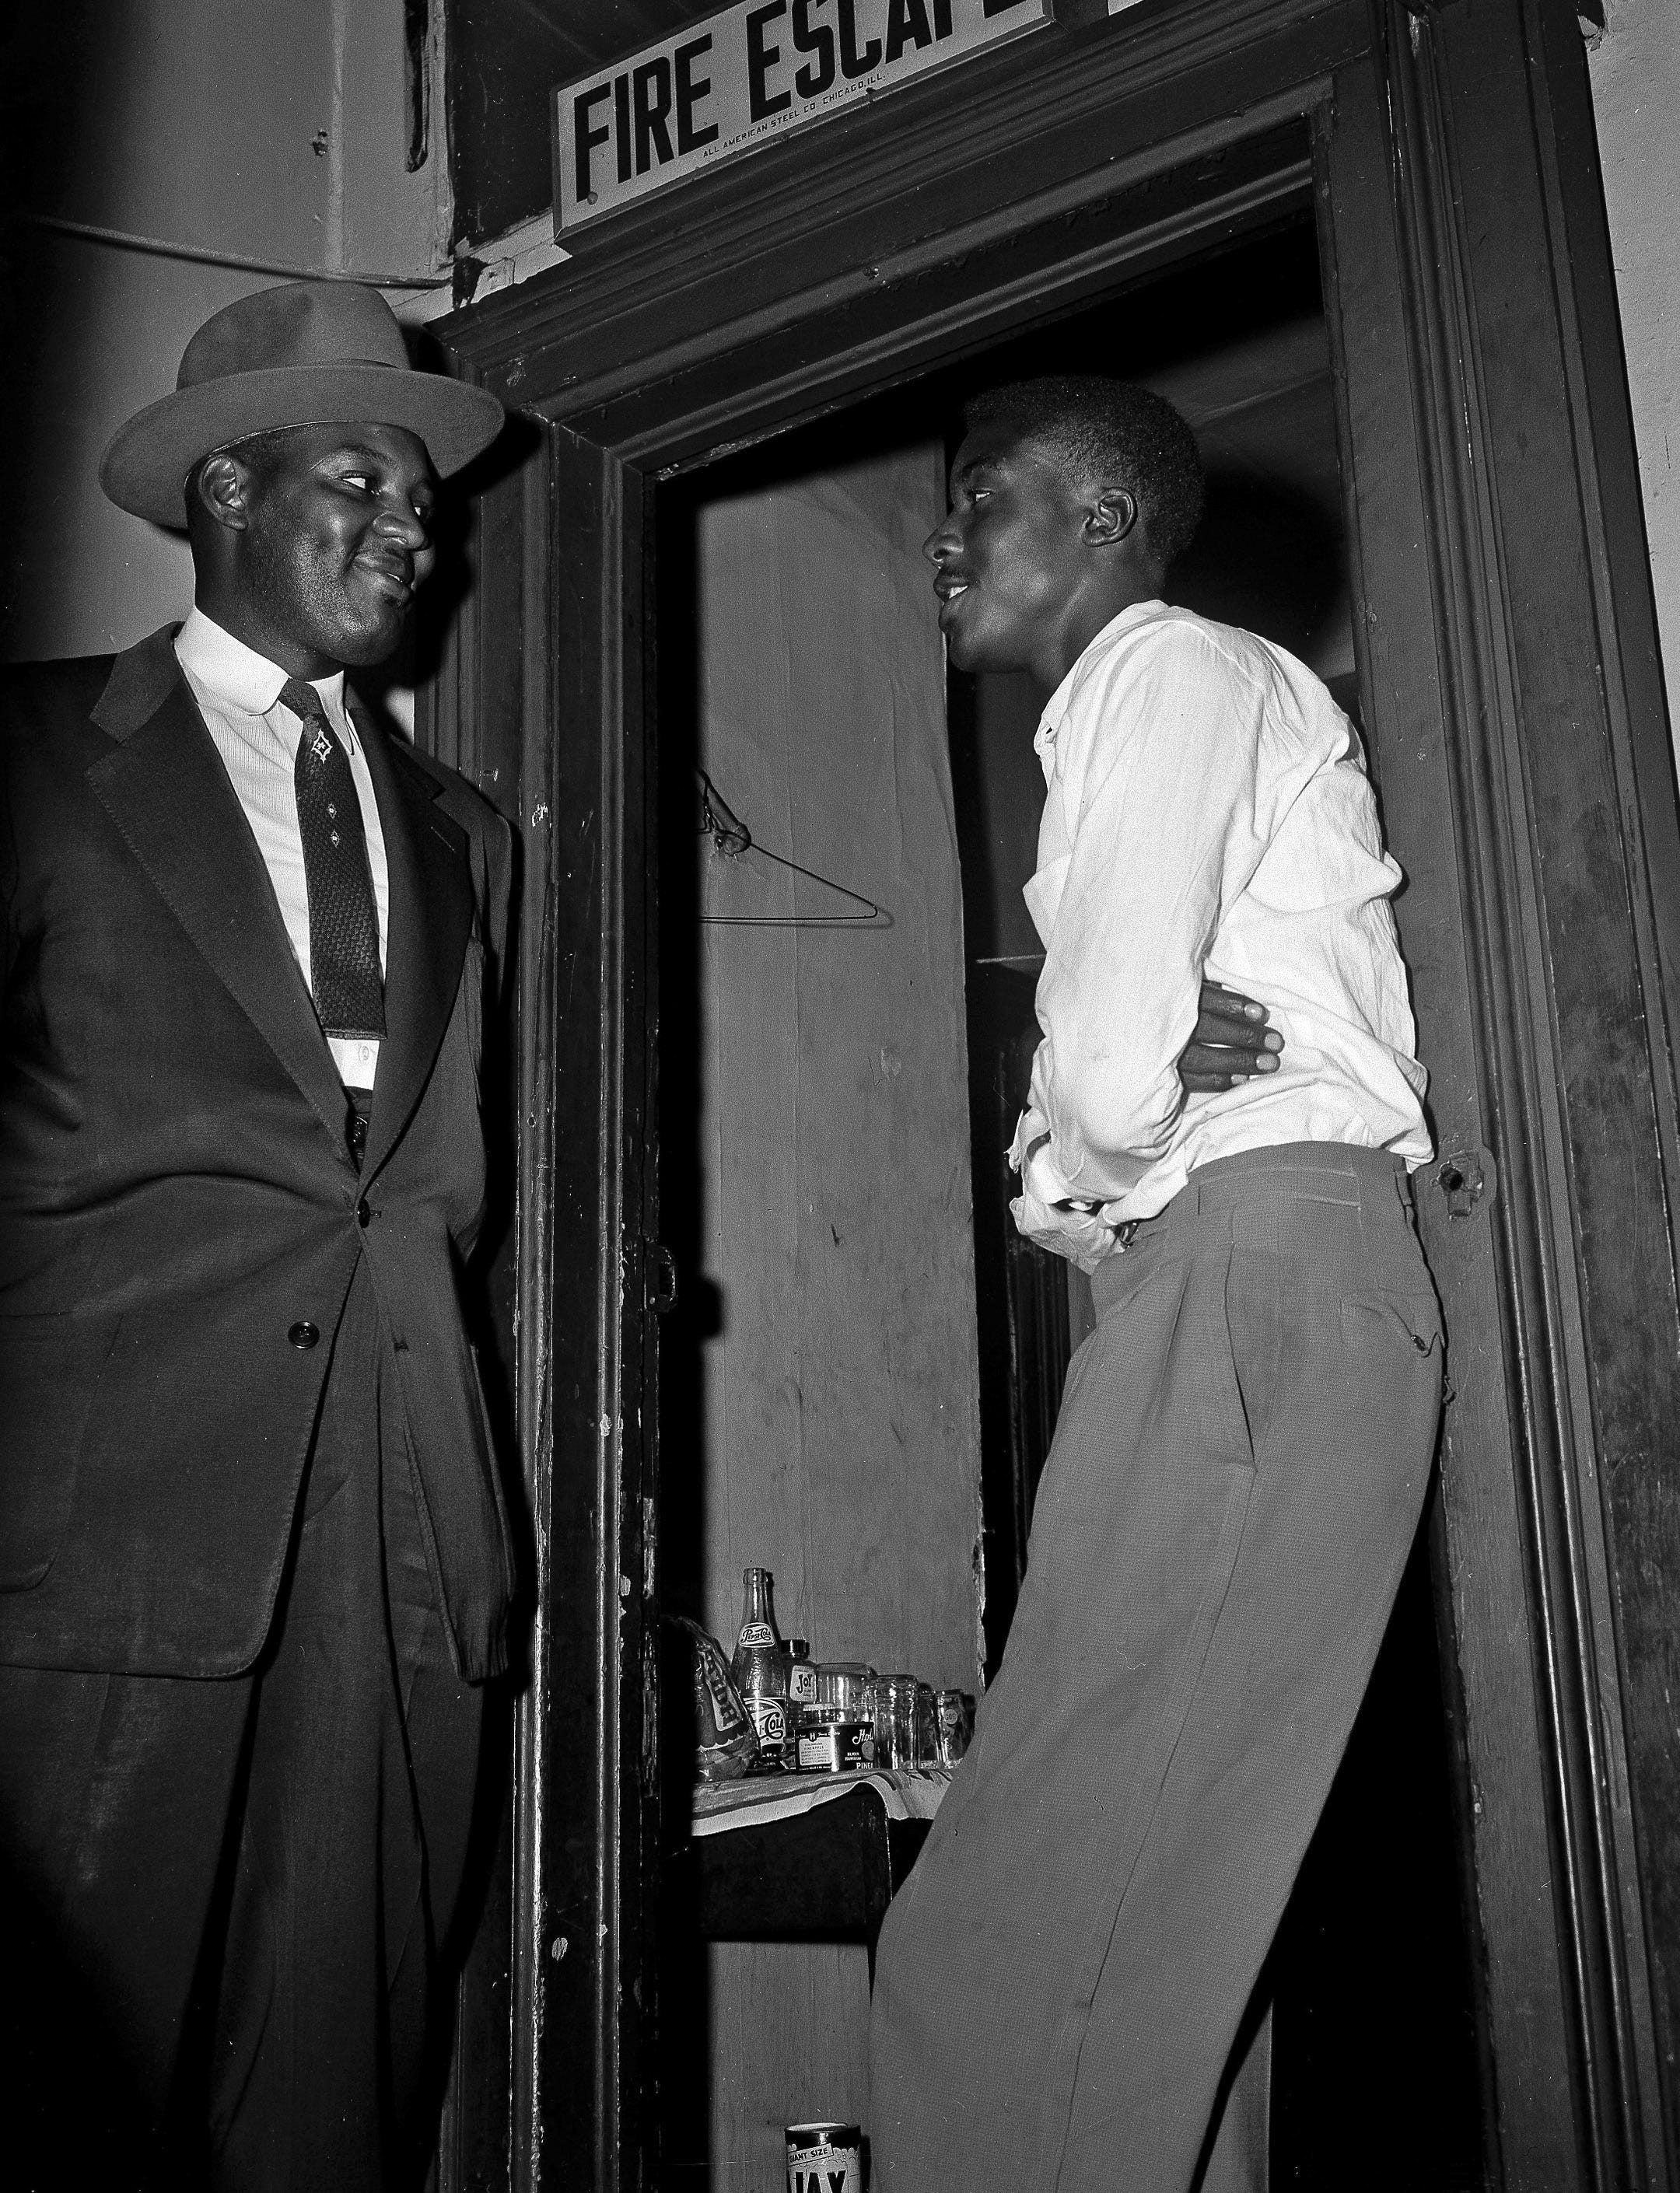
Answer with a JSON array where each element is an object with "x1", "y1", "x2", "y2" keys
[{"x1": 88, "y1": 628, "x2": 345, "y2": 1149}]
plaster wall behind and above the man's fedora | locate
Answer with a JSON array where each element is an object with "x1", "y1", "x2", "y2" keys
[{"x1": 0, "y1": 0, "x2": 447, "y2": 660}]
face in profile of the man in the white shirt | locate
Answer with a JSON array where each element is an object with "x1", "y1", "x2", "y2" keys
[{"x1": 921, "y1": 425, "x2": 1086, "y2": 671}]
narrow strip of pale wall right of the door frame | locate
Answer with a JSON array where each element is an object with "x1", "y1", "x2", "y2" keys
[{"x1": 1588, "y1": 0, "x2": 1680, "y2": 754}]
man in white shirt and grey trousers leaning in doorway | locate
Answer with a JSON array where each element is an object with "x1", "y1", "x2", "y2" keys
[{"x1": 870, "y1": 377, "x2": 1441, "y2": 2193}]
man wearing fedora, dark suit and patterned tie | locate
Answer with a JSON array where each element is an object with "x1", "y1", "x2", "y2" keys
[{"x1": 0, "y1": 283, "x2": 513, "y2": 2188}]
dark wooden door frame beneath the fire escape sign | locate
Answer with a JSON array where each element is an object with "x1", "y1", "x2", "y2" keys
[{"x1": 432, "y1": 0, "x2": 1680, "y2": 2188}]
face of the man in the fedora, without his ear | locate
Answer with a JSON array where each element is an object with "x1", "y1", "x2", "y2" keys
[{"x1": 235, "y1": 425, "x2": 436, "y2": 666}]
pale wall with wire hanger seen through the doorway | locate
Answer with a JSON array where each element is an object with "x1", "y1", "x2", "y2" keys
[{"x1": 653, "y1": 414, "x2": 978, "y2": 2193}]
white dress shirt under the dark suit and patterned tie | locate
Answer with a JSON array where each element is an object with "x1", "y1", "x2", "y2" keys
[{"x1": 176, "y1": 610, "x2": 390, "y2": 1090}]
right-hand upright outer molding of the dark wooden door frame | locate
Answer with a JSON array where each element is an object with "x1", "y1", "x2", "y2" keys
[{"x1": 1391, "y1": 0, "x2": 1680, "y2": 2187}]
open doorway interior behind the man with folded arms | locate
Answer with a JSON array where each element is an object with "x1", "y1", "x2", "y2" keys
[{"x1": 653, "y1": 213, "x2": 1482, "y2": 2193}]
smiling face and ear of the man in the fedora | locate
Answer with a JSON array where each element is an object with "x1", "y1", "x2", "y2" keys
[{"x1": 195, "y1": 425, "x2": 436, "y2": 677}]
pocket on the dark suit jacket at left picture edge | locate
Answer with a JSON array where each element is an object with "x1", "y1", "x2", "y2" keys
[{"x1": 0, "y1": 1311, "x2": 121, "y2": 1592}]
